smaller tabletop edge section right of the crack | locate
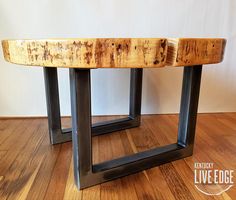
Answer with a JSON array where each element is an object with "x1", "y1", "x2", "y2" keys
[{"x1": 167, "y1": 38, "x2": 226, "y2": 67}]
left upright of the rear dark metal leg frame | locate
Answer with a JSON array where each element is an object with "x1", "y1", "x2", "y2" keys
[{"x1": 44, "y1": 67, "x2": 71, "y2": 144}]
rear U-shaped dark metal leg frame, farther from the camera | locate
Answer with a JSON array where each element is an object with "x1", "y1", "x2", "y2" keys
[{"x1": 44, "y1": 67, "x2": 143, "y2": 144}]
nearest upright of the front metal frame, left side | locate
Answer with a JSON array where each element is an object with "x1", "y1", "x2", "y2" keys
[{"x1": 70, "y1": 69, "x2": 92, "y2": 187}]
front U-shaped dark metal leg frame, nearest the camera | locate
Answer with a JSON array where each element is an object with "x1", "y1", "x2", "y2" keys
[{"x1": 70, "y1": 66, "x2": 202, "y2": 189}]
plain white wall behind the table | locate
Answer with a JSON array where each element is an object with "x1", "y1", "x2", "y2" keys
[{"x1": 0, "y1": 0, "x2": 236, "y2": 116}]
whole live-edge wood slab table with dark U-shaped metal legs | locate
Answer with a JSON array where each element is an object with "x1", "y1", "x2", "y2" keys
[{"x1": 2, "y1": 38, "x2": 226, "y2": 189}]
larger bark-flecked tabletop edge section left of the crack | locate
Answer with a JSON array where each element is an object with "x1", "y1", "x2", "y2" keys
[{"x1": 2, "y1": 38, "x2": 167, "y2": 68}]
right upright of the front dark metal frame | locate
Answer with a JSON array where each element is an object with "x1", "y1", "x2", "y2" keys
[{"x1": 178, "y1": 65, "x2": 202, "y2": 147}]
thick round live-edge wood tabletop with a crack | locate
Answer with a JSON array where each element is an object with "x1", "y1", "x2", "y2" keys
[{"x1": 2, "y1": 38, "x2": 226, "y2": 68}]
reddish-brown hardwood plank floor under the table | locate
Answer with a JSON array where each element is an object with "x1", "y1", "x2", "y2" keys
[{"x1": 0, "y1": 113, "x2": 236, "y2": 200}]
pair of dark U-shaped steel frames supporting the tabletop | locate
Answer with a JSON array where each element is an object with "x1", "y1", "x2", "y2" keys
[{"x1": 44, "y1": 66, "x2": 202, "y2": 189}]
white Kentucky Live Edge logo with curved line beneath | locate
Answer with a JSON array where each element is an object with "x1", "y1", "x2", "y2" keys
[{"x1": 194, "y1": 163, "x2": 234, "y2": 195}]
